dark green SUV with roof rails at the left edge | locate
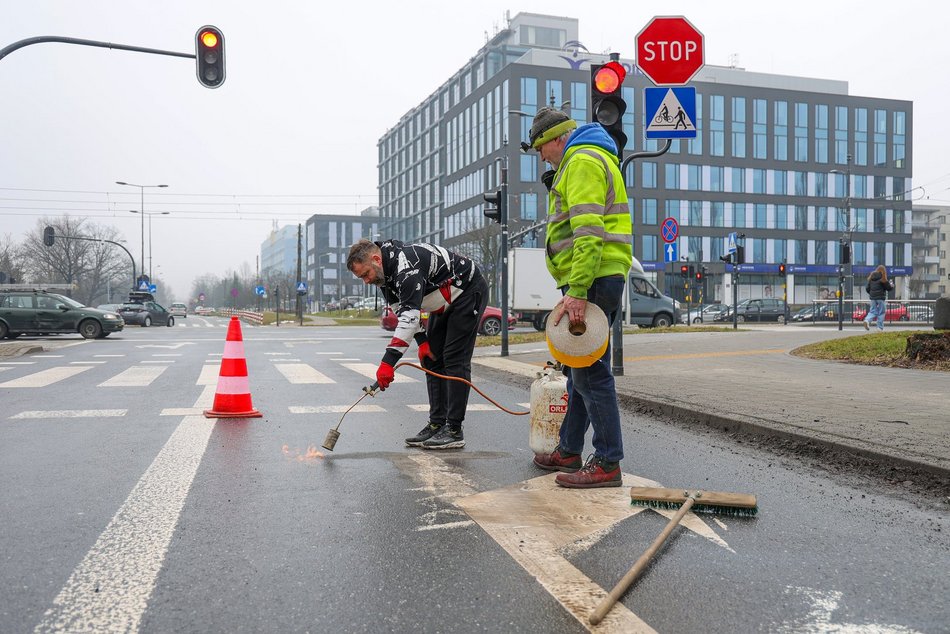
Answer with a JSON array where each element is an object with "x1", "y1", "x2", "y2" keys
[{"x1": 0, "y1": 290, "x2": 125, "y2": 339}]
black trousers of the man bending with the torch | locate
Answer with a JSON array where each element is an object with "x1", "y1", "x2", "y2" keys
[{"x1": 426, "y1": 274, "x2": 488, "y2": 427}]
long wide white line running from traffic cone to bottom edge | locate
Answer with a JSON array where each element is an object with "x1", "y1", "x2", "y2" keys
[{"x1": 34, "y1": 416, "x2": 214, "y2": 634}]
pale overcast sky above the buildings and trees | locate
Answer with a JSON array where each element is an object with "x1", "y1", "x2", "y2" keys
[{"x1": 0, "y1": 0, "x2": 950, "y2": 300}]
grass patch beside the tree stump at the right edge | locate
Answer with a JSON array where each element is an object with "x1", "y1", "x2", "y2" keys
[{"x1": 792, "y1": 330, "x2": 950, "y2": 372}]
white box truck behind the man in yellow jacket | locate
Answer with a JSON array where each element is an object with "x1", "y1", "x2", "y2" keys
[{"x1": 508, "y1": 247, "x2": 679, "y2": 331}]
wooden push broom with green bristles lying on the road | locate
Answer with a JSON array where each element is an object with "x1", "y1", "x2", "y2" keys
[{"x1": 588, "y1": 487, "x2": 758, "y2": 625}]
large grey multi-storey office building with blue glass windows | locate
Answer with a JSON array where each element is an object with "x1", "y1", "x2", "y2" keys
[{"x1": 378, "y1": 13, "x2": 913, "y2": 303}]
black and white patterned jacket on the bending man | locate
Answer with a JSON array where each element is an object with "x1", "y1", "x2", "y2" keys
[{"x1": 376, "y1": 240, "x2": 481, "y2": 365}]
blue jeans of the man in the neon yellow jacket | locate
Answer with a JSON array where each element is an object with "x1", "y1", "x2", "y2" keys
[{"x1": 560, "y1": 276, "x2": 624, "y2": 462}]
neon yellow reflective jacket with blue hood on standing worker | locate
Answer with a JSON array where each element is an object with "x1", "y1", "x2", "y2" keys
[{"x1": 545, "y1": 123, "x2": 633, "y2": 299}]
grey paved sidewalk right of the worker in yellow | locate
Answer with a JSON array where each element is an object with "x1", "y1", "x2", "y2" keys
[{"x1": 474, "y1": 326, "x2": 950, "y2": 478}]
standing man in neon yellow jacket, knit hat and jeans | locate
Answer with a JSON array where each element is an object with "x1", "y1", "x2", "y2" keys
[{"x1": 522, "y1": 108, "x2": 633, "y2": 488}]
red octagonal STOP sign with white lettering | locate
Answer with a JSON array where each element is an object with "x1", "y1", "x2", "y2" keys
[{"x1": 637, "y1": 15, "x2": 705, "y2": 86}]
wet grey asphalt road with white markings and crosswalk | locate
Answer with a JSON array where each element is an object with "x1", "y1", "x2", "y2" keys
[{"x1": 0, "y1": 317, "x2": 950, "y2": 633}]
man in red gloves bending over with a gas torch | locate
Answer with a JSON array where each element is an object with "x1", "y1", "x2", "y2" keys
[{"x1": 346, "y1": 239, "x2": 488, "y2": 449}]
